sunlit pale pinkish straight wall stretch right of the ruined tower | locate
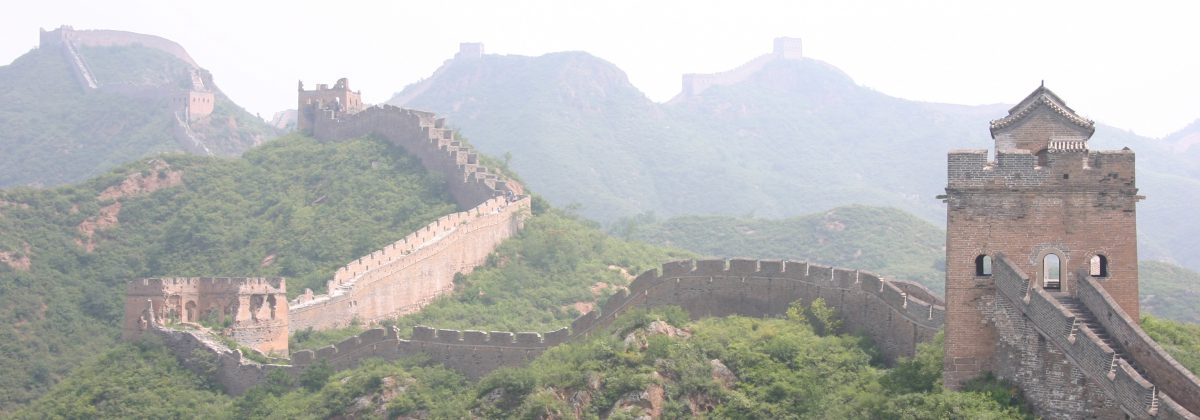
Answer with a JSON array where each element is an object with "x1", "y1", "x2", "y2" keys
[{"x1": 289, "y1": 197, "x2": 529, "y2": 331}]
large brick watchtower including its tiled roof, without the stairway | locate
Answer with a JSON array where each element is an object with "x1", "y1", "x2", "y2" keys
[{"x1": 944, "y1": 86, "x2": 1142, "y2": 388}]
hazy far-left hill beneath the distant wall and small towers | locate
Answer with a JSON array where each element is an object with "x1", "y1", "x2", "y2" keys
[{"x1": 0, "y1": 44, "x2": 274, "y2": 187}]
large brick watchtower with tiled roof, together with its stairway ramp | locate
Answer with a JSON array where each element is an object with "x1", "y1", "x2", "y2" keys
[{"x1": 943, "y1": 86, "x2": 1200, "y2": 419}]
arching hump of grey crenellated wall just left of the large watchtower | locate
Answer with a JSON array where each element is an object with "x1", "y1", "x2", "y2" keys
[{"x1": 571, "y1": 259, "x2": 944, "y2": 361}]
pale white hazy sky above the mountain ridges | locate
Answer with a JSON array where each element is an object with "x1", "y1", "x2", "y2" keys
[{"x1": 0, "y1": 0, "x2": 1200, "y2": 137}]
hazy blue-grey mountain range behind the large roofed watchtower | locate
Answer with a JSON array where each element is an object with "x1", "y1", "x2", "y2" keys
[{"x1": 389, "y1": 41, "x2": 1200, "y2": 269}]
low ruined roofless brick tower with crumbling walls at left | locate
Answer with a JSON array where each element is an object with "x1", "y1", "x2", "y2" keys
[{"x1": 121, "y1": 277, "x2": 288, "y2": 354}]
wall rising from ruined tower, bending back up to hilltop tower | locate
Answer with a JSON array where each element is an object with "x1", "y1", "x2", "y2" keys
[{"x1": 289, "y1": 98, "x2": 532, "y2": 331}]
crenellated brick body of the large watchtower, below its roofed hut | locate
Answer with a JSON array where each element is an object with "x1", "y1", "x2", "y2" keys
[{"x1": 944, "y1": 140, "x2": 1140, "y2": 388}]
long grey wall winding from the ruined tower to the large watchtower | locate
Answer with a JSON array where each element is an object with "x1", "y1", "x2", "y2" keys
[{"x1": 142, "y1": 259, "x2": 944, "y2": 394}]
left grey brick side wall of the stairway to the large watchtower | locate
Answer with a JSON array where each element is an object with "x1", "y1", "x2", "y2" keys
[{"x1": 982, "y1": 254, "x2": 1195, "y2": 419}]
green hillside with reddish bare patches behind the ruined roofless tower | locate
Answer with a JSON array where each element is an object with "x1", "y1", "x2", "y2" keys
[{"x1": 0, "y1": 136, "x2": 455, "y2": 413}]
